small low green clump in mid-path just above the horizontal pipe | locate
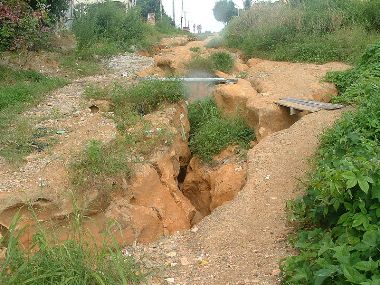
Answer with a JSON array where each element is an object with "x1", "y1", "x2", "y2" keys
[{"x1": 187, "y1": 51, "x2": 234, "y2": 73}]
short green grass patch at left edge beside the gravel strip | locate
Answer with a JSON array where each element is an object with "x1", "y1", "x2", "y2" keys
[{"x1": 0, "y1": 63, "x2": 67, "y2": 164}]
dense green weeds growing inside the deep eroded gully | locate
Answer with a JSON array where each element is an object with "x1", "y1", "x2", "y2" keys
[{"x1": 189, "y1": 99, "x2": 255, "y2": 162}]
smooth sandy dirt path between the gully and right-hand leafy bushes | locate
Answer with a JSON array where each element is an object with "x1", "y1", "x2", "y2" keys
[{"x1": 129, "y1": 107, "x2": 341, "y2": 285}]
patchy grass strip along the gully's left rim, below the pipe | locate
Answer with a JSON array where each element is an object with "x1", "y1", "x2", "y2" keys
[{"x1": 72, "y1": 81, "x2": 184, "y2": 190}]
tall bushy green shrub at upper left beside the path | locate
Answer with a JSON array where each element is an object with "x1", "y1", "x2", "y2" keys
[{"x1": 73, "y1": 1, "x2": 152, "y2": 57}]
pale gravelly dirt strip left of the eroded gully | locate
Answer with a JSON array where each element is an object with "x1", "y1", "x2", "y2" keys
[{"x1": 0, "y1": 54, "x2": 153, "y2": 217}]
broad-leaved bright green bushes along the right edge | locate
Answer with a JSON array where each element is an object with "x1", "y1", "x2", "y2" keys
[{"x1": 282, "y1": 44, "x2": 380, "y2": 285}]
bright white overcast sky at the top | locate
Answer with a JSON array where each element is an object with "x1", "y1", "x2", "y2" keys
[{"x1": 162, "y1": 0, "x2": 243, "y2": 32}]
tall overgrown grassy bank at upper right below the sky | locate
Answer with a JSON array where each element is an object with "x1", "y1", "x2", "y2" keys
[{"x1": 224, "y1": 0, "x2": 380, "y2": 63}]
